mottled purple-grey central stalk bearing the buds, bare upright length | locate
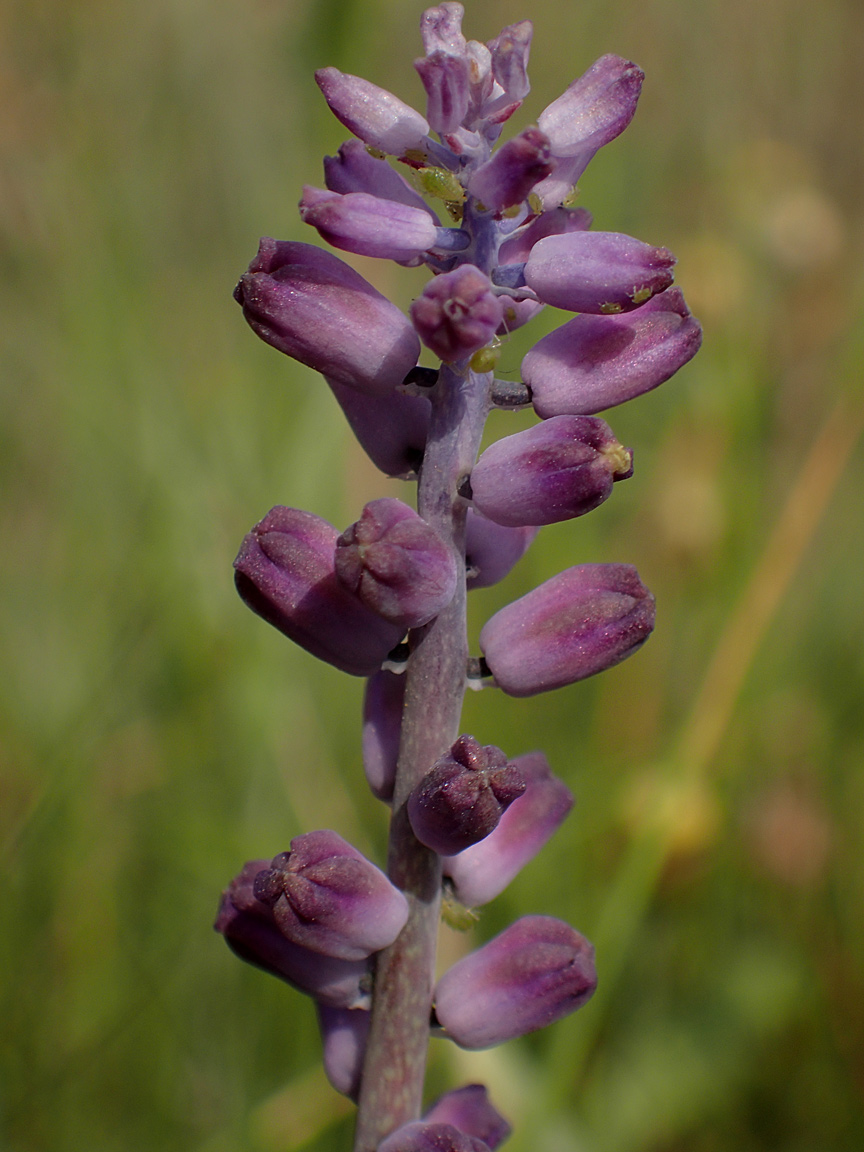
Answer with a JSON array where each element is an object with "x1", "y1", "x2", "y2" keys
[{"x1": 354, "y1": 364, "x2": 492, "y2": 1152}]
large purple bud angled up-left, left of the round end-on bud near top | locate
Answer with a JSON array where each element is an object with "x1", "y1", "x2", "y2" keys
[{"x1": 234, "y1": 236, "x2": 419, "y2": 396}]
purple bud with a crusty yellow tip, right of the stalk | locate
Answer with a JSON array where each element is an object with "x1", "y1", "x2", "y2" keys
[{"x1": 471, "y1": 416, "x2": 632, "y2": 528}]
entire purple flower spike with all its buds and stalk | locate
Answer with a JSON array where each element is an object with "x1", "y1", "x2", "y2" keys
[{"x1": 217, "y1": 2, "x2": 702, "y2": 1152}]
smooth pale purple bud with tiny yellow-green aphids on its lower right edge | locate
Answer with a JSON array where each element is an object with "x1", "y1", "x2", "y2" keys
[{"x1": 524, "y1": 232, "x2": 675, "y2": 313}]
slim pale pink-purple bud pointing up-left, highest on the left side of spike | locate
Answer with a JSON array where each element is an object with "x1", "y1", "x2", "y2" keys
[{"x1": 314, "y1": 68, "x2": 429, "y2": 156}]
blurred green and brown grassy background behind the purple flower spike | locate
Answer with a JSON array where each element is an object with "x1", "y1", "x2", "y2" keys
[{"x1": 0, "y1": 0, "x2": 864, "y2": 1152}]
